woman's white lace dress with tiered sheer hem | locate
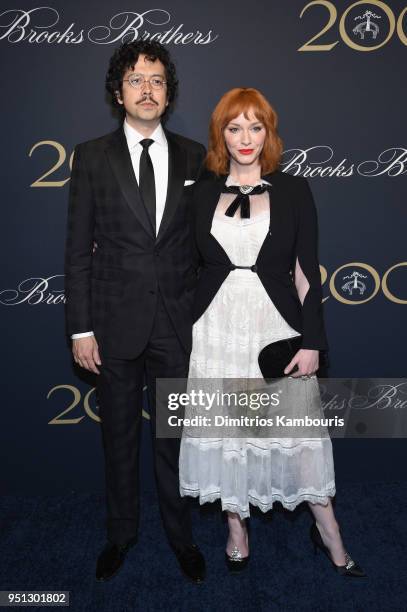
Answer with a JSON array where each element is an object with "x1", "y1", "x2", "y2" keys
[{"x1": 179, "y1": 177, "x2": 335, "y2": 518}]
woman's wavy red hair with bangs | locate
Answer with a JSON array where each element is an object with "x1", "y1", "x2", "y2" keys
[{"x1": 205, "y1": 87, "x2": 283, "y2": 175}]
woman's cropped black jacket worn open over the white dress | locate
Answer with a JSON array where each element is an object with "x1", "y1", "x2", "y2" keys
[{"x1": 192, "y1": 170, "x2": 328, "y2": 350}]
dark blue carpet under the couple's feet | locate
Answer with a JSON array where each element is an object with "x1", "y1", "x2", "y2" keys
[{"x1": 0, "y1": 482, "x2": 407, "y2": 612}]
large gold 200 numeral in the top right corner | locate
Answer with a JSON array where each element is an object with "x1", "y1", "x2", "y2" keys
[{"x1": 298, "y1": 0, "x2": 407, "y2": 51}]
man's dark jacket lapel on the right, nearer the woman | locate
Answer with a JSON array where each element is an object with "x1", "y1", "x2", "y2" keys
[{"x1": 157, "y1": 131, "x2": 187, "y2": 242}]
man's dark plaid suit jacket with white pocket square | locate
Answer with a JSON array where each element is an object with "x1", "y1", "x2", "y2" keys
[{"x1": 65, "y1": 127, "x2": 205, "y2": 359}]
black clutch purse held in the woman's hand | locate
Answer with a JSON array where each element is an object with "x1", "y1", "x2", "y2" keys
[{"x1": 259, "y1": 336, "x2": 328, "y2": 379}]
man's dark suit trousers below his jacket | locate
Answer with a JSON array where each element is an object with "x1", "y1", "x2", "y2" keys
[{"x1": 98, "y1": 293, "x2": 193, "y2": 550}]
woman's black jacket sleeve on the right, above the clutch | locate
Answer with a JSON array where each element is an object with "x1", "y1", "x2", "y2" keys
[{"x1": 296, "y1": 178, "x2": 328, "y2": 351}]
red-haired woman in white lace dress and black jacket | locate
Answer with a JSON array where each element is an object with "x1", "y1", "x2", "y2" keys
[{"x1": 179, "y1": 88, "x2": 364, "y2": 576}]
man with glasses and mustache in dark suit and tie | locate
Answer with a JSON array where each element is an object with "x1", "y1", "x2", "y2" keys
[{"x1": 65, "y1": 41, "x2": 209, "y2": 582}]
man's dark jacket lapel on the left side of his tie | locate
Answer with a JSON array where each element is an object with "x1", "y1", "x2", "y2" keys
[{"x1": 106, "y1": 127, "x2": 154, "y2": 237}]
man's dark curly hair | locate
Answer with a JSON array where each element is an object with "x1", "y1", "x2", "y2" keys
[{"x1": 105, "y1": 40, "x2": 178, "y2": 121}]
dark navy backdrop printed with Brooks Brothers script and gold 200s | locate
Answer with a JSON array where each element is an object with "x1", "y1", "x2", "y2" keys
[{"x1": 0, "y1": 0, "x2": 407, "y2": 494}]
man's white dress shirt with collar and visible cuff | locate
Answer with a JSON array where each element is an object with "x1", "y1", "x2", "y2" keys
[{"x1": 71, "y1": 120, "x2": 168, "y2": 340}]
